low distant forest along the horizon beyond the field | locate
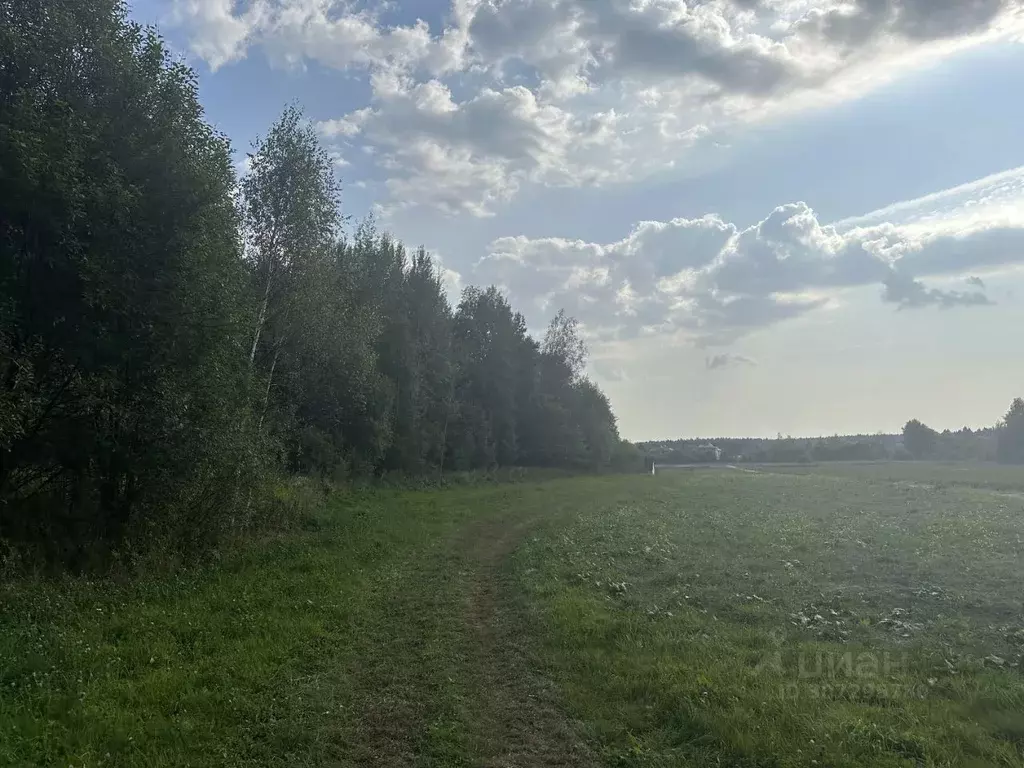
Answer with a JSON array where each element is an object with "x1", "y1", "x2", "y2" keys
[{"x1": 638, "y1": 397, "x2": 1024, "y2": 465}]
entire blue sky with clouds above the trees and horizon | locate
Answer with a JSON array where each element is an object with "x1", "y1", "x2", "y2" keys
[{"x1": 131, "y1": 0, "x2": 1024, "y2": 440}]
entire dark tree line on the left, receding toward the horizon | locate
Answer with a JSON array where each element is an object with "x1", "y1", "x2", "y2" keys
[{"x1": 0, "y1": 0, "x2": 639, "y2": 562}]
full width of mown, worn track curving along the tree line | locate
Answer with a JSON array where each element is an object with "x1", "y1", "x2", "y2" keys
[{"x1": 339, "y1": 509, "x2": 598, "y2": 768}]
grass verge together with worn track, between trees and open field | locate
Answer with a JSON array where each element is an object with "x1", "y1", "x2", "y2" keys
[{"x1": 0, "y1": 481, "x2": 592, "y2": 768}]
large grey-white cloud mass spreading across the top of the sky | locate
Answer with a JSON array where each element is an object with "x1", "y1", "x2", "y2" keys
[{"x1": 171, "y1": 0, "x2": 1024, "y2": 215}]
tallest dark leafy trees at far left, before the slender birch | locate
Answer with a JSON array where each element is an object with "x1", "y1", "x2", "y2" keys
[{"x1": 0, "y1": 0, "x2": 252, "y2": 559}]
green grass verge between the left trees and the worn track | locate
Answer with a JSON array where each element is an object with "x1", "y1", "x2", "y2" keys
[{"x1": 0, "y1": 492, "x2": 477, "y2": 766}]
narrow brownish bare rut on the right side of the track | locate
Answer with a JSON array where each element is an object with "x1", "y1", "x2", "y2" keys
[{"x1": 464, "y1": 518, "x2": 597, "y2": 768}]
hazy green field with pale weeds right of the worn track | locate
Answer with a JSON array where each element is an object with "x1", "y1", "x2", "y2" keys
[{"x1": 517, "y1": 471, "x2": 1024, "y2": 766}]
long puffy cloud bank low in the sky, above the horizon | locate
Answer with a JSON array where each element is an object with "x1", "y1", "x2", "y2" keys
[{"x1": 473, "y1": 179, "x2": 1024, "y2": 346}]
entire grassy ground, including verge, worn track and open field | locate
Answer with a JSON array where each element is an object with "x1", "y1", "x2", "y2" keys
[{"x1": 0, "y1": 465, "x2": 1024, "y2": 766}]
